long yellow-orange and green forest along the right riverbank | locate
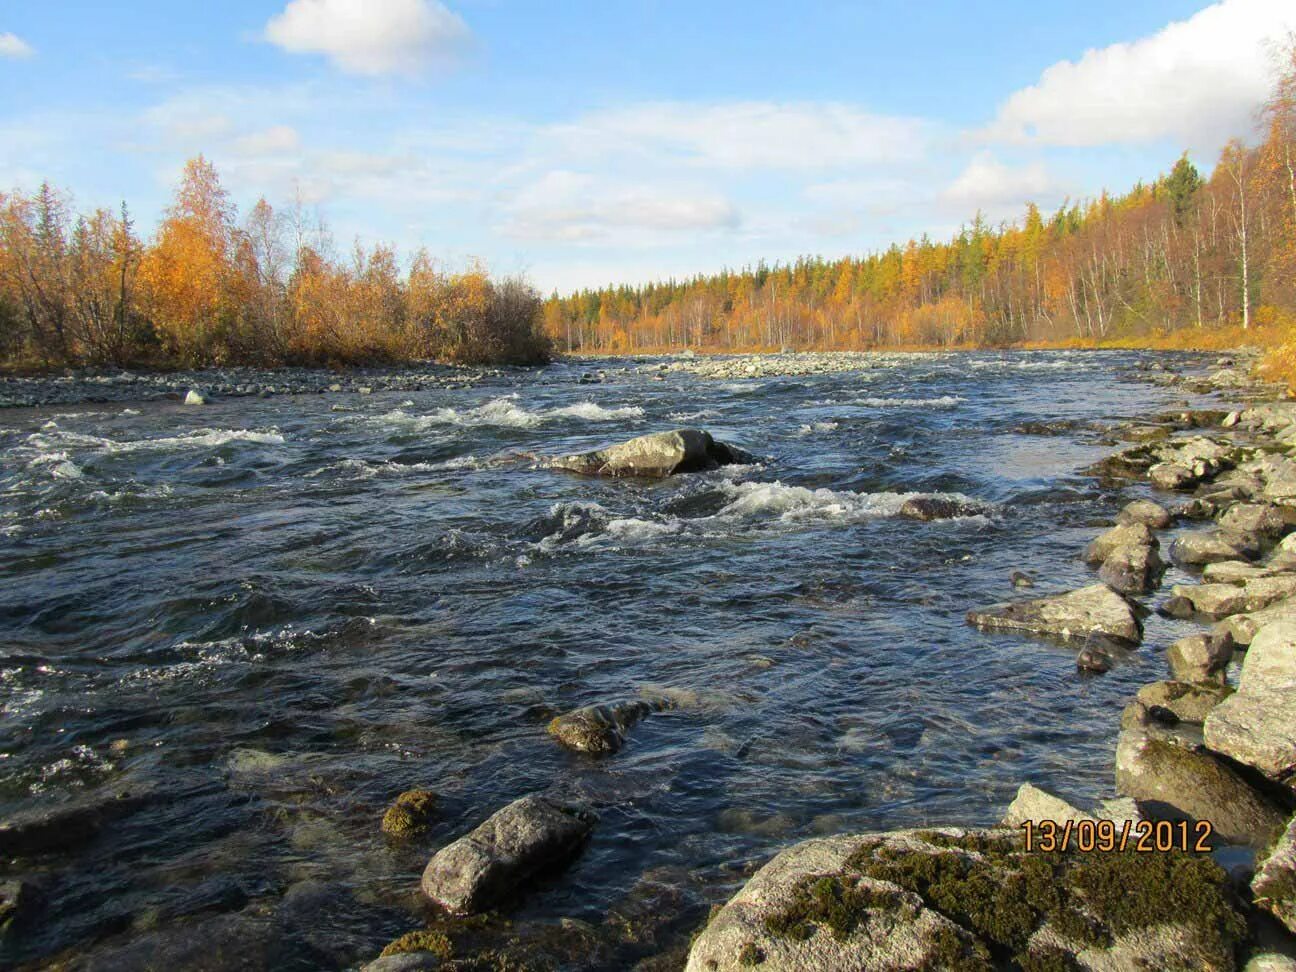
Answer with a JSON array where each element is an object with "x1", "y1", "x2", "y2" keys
[{"x1": 544, "y1": 47, "x2": 1296, "y2": 351}]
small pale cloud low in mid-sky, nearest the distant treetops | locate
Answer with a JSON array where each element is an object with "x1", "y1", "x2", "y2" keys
[{"x1": 503, "y1": 171, "x2": 740, "y2": 242}]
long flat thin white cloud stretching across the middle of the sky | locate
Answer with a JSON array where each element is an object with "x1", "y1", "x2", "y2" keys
[{"x1": 547, "y1": 101, "x2": 931, "y2": 170}]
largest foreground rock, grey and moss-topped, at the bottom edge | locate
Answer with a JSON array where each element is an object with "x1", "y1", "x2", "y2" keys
[{"x1": 686, "y1": 829, "x2": 1245, "y2": 972}]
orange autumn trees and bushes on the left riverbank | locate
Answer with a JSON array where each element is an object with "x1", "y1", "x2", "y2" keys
[{"x1": 0, "y1": 156, "x2": 551, "y2": 368}]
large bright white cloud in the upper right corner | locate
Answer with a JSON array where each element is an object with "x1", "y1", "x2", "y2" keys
[{"x1": 984, "y1": 0, "x2": 1296, "y2": 149}]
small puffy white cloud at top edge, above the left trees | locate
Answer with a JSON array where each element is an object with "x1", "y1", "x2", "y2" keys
[{"x1": 266, "y1": 0, "x2": 469, "y2": 75}]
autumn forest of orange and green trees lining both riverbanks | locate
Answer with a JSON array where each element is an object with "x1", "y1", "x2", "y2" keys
[{"x1": 0, "y1": 47, "x2": 1296, "y2": 376}]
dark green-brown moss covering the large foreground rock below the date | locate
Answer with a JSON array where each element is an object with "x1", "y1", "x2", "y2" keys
[{"x1": 765, "y1": 832, "x2": 1245, "y2": 972}]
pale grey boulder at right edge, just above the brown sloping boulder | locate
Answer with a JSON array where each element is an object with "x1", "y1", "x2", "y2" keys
[{"x1": 1204, "y1": 684, "x2": 1296, "y2": 783}]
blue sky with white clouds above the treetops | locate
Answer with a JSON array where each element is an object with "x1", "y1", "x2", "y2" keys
[{"x1": 0, "y1": 0, "x2": 1296, "y2": 293}]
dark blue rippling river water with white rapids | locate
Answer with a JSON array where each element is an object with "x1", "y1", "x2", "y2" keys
[{"x1": 0, "y1": 353, "x2": 1213, "y2": 969}]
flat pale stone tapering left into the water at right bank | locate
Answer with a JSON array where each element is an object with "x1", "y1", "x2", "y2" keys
[{"x1": 967, "y1": 584, "x2": 1143, "y2": 644}]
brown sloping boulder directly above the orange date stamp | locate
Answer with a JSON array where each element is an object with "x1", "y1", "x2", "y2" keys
[{"x1": 1116, "y1": 720, "x2": 1286, "y2": 848}]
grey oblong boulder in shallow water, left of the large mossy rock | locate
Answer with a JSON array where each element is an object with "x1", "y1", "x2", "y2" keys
[{"x1": 422, "y1": 796, "x2": 597, "y2": 914}]
